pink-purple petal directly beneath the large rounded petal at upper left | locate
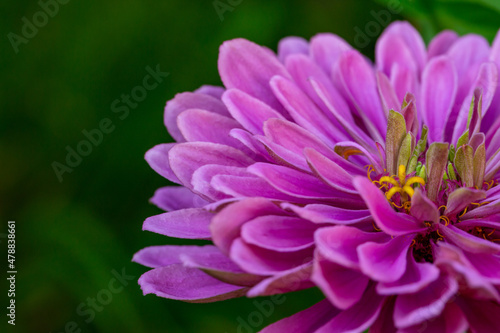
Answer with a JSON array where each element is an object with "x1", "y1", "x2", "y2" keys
[{"x1": 222, "y1": 89, "x2": 284, "y2": 134}]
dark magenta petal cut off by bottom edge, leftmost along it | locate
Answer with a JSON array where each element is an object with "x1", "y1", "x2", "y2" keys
[{"x1": 259, "y1": 300, "x2": 339, "y2": 333}]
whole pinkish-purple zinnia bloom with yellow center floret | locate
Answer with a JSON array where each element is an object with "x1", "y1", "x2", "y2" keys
[{"x1": 134, "y1": 22, "x2": 500, "y2": 333}]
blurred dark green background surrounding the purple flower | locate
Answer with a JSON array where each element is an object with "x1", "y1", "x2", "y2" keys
[{"x1": 0, "y1": 0, "x2": 500, "y2": 333}]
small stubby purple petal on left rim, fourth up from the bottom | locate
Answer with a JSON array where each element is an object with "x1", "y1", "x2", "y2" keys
[{"x1": 150, "y1": 186, "x2": 208, "y2": 211}]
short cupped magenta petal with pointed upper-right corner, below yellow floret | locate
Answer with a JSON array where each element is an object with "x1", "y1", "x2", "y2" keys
[{"x1": 357, "y1": 235, "x2": 413, "y2": 282}]
